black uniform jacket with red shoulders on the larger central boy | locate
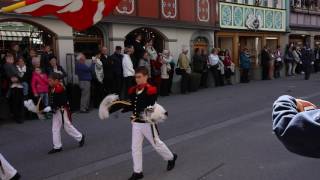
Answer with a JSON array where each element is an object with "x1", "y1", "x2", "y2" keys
[{"x1": 129, "y1": 84, "x2": 158, "y2": 123}]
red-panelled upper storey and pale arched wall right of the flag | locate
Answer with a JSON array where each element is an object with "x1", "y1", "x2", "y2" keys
[{"x1": 106, "y1": 0, "x2": 216, "y2": 58}]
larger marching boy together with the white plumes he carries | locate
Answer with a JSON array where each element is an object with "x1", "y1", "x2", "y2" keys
[{"x1": 99, "y1": 67, "x2": 178, "y2": 180}]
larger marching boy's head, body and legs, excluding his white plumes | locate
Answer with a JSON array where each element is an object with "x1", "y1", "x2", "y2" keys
[{"x1": 127, "y1": 67, "x2": 177, "y2": 180}]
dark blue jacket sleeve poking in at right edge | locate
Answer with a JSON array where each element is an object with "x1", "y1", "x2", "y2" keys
[{"x1": 272, "y1": 96, "x2": 320, "y2": 158}]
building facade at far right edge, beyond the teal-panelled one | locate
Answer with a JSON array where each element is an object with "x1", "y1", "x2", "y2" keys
[{"x1": 289, "y1": 0, "x2": 320, "y2": 48}]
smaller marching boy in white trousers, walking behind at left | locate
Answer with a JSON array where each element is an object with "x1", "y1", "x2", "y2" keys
[{"x1": 48, "y1": 73, "x2": 85, "y2": 154}]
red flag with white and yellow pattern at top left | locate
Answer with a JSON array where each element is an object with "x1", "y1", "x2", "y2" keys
[{"x1": 1, "y1": 0, "x2": 120, "y2": 30}]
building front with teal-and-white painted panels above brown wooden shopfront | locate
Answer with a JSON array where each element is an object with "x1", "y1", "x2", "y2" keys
[{"x1": 216, "y1": 0, "x2": 288, "y2": 80}]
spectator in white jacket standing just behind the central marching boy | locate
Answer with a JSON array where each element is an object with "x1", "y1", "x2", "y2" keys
[{"x1": 122, "y1": 45, "x2": 135, "y2": 98}]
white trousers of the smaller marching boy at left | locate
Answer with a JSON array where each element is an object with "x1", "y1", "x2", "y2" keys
[{"x1": 52, "y1": 110, "x2": 82, "y2": 149}]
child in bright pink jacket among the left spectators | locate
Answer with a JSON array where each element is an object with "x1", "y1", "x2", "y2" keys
[{"x1": 31, "y1": 67, "x2": 49, "y2": 107}]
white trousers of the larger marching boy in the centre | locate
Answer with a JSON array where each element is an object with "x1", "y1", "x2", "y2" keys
[{"x1": 131, "y1": 123, "x2": 173, "y2": 173}]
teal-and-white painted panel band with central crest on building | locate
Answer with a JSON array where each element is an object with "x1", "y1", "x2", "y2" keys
[{"x1": 219, "y1": 2, "x2": 286, "y2": 32}]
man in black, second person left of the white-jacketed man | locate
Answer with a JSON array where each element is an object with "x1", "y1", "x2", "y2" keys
[{"x1": 100, "y1": 47, "x2": 114, "y2": 95}]
